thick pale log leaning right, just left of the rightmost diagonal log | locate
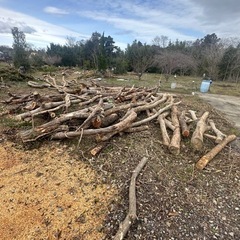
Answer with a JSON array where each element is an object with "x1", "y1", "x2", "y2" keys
[{"x1": 191, "y1": 112, "x2": 209, "y2": 150}]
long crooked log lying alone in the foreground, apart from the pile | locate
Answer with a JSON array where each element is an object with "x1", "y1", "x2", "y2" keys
[{"x1": 114, "y1": 157, "x2": 148, "y2": 240}]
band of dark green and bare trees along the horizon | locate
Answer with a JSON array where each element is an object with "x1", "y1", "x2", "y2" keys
[{"x1": 0, "y1": 27, "x2": 240, "y2": 82}]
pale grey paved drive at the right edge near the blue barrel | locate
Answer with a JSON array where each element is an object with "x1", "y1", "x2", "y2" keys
[{"x1": 199, "y1": 93, "x2": 240, "y2": 129}]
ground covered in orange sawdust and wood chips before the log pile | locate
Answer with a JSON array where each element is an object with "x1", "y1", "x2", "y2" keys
[{"x1": 0, "y1": 76, "x2": 240, "y2": 240}]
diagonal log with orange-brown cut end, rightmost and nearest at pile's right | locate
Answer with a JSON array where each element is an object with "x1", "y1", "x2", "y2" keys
[{"x1": 196, "y1": 135, "x2": 237, "y2": 170}]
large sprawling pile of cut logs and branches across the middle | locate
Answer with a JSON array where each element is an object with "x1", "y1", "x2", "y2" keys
[{"x1": 0, "y1": 76, "x2": 236, "y2": 169}]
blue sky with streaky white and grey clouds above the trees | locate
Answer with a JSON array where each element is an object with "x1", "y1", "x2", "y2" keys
[{"x1": 0, "y1": 0, "x2": 240, "y2": 49}]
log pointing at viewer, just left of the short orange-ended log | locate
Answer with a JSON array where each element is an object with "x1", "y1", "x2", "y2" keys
[{"x1": 168, "y1": 105, "x2": 181, "y2": 155}]
